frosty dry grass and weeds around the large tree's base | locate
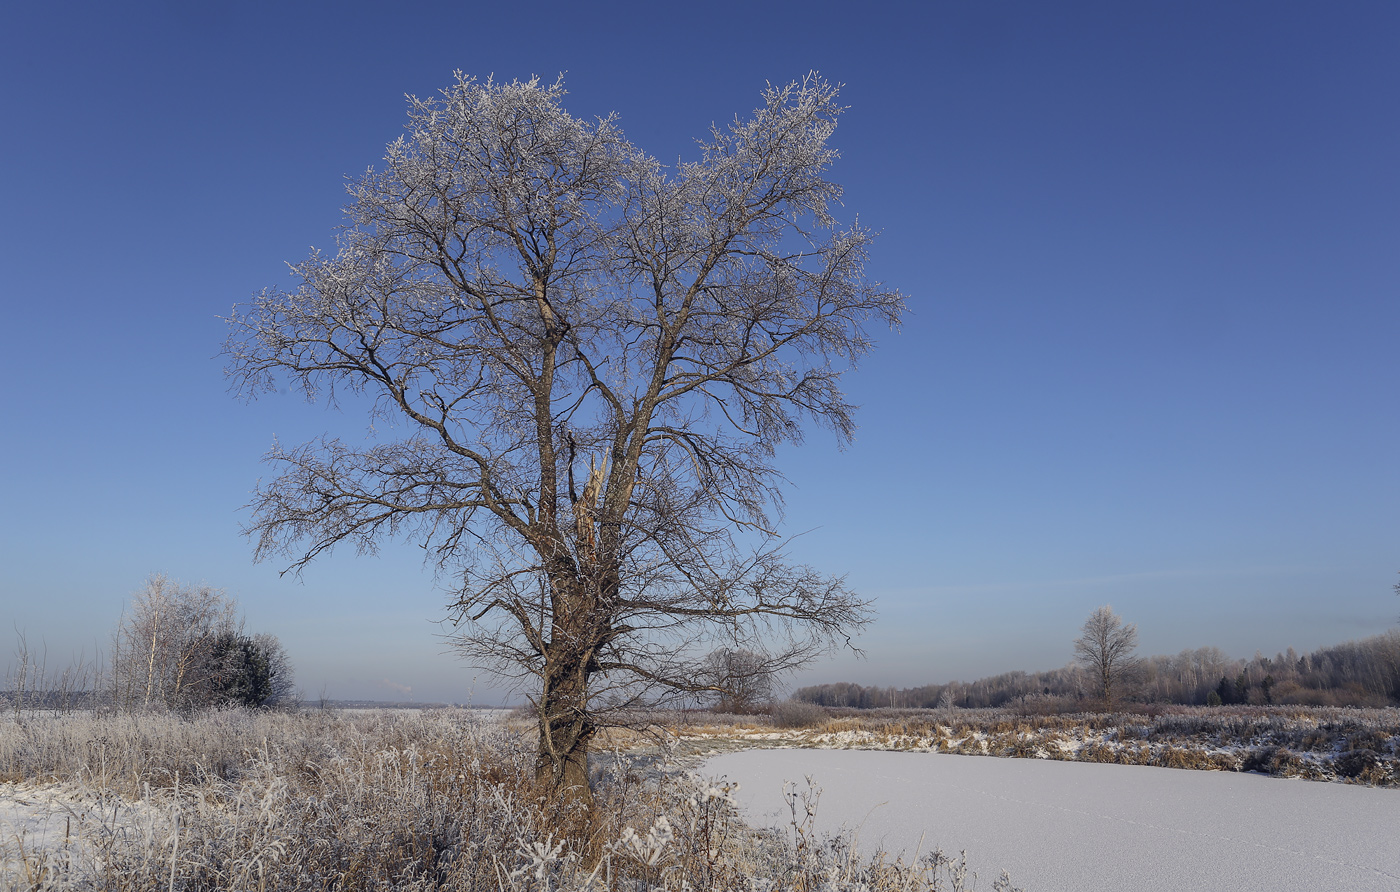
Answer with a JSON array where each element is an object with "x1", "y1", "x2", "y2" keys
[{"x1": 0, "y1": 710, "x2": 1030, "y2": 892}]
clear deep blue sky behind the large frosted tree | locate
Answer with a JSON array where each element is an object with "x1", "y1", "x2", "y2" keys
[{"x1": 0, "y1": 0, "x2": 1400, "y2": 703}]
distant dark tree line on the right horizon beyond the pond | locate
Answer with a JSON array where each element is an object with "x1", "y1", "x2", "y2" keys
[{"x1": 792, "y1": 630, "x2": 1400, "y2": 709}]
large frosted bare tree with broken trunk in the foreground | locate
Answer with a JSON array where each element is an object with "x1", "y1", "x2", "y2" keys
[{"x1": 225, "y1": 73, "x2": 903, "y2": 801}]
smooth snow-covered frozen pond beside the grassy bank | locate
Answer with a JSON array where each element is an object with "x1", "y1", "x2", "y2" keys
[{"x1": 703, "y1": 749, "x2": 1400, "y2": 892}]
